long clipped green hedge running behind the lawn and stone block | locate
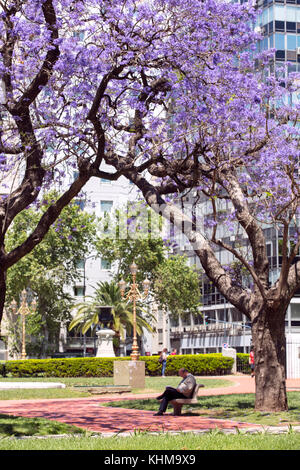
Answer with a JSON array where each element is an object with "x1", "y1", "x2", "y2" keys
[{"x1": 0, "y1": 353, "x2": 233, "y2": 377}]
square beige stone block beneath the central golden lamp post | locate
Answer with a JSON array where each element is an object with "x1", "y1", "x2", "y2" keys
[{"x1": 114, "y1": 361, "x2": 145, "y2": 388}]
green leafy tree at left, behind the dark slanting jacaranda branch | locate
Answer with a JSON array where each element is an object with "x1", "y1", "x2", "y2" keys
[{"x1": 5, "y1": 192, "x2": 96, "y2": 356}]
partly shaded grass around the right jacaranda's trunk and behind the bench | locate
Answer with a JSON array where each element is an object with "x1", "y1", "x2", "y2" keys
[{"x1": 102, "y1": 392, "x2": 300, "y2": 426}]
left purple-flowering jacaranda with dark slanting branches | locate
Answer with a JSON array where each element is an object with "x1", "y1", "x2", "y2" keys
[{"x1": 0, "y1": 0, "x2": 174, "y2": 319}]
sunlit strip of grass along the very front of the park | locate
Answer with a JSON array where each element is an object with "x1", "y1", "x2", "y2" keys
[{"x1": 0, "y1": 430, "x2": 300, "y2": 450}]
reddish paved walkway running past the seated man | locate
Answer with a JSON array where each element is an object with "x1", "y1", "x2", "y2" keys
[{"x1": 0, "y1": 376, "x2": 300, "y2": 435}]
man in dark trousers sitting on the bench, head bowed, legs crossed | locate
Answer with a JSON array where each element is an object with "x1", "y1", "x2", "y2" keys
[{"x1": 154, "y1": 368, "x2": 196, "y2": 416}]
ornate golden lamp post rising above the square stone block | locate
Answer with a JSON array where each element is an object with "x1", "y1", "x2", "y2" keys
[{"x1": 119, "y1": 262, "x2": 150, "y2": 361}]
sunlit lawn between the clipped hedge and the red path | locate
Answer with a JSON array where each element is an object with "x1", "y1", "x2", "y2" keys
[{"x1": 0, "y1": 377, "x2": 232, "y2": 400}]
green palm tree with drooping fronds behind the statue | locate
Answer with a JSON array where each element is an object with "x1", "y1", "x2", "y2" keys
[{"x1": 69, "y1": 281, "x2": 155, "y2": 346}]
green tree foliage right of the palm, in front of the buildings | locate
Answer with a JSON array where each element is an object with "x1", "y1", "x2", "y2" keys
[{"x1": 96, "y1": 204, "x2": 201, "y2": 316}]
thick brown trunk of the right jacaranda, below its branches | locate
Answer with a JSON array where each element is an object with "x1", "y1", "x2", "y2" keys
[{"x1": 252, "y1": 304, "x2": 288, "y2": 412}]
